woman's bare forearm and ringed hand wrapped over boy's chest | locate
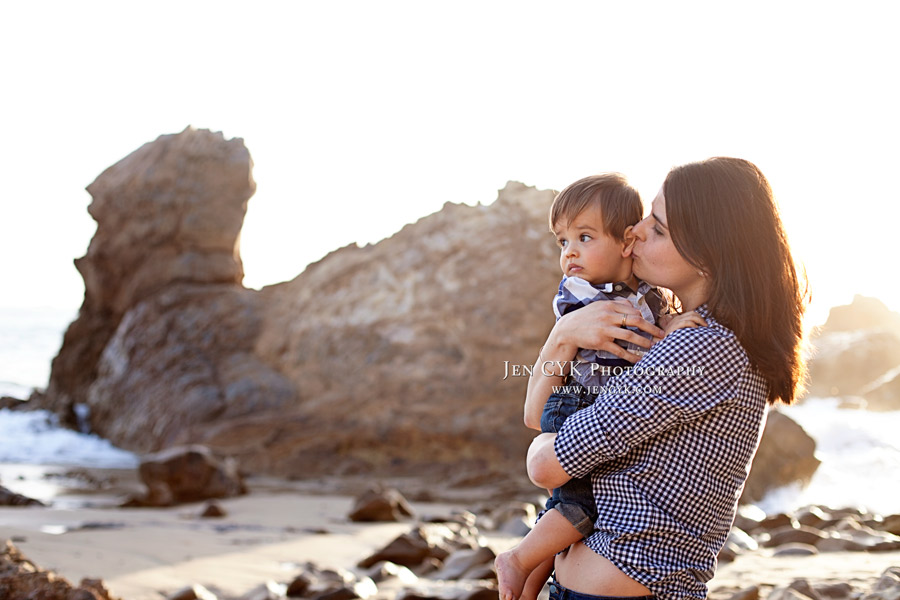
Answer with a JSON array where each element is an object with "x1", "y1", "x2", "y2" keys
[{"x1": 525, "y1": 301, "x2": 664, "y2": 431}]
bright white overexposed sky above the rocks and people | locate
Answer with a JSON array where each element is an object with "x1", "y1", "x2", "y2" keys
[{"x1": 0, "y1": 0, "x2": 900, "y2": 321}]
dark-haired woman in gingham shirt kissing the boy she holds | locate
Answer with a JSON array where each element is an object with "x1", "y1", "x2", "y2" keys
[{"x1": 528, "y1": 158, "x2": 804, "y2": 600}]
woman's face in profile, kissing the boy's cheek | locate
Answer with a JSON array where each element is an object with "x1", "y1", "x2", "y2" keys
[{"x1": 631, "y1": 189, "x2": 709, "y2": 310}]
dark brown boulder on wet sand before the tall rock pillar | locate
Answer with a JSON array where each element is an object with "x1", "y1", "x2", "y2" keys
[{"x1": 125, "y1": 445, "x2": 247, "y2": 506}]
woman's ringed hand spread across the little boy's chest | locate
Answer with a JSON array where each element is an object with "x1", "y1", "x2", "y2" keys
[{"x1": 541, "y1": 300, "x2": 665, "y2": 363}]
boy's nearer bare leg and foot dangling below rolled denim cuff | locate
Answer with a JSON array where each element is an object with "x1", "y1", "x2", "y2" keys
[{"x1": 494, "y1": 508, "x2": 583, "y2": 600}]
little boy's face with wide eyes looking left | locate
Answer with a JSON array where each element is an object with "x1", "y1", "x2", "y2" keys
[{"x1": 553, "y1": 207, "x2": 631, "y2": 285}]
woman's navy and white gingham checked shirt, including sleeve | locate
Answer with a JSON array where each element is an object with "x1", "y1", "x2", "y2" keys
[{"x1": 555, "y1": 305, "x2": 767, "y2": 600}]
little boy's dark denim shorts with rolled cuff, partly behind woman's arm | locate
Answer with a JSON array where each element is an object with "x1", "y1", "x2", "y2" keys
[{"x1": 541, "y1": 387, "x2": 597, "y2": 537}]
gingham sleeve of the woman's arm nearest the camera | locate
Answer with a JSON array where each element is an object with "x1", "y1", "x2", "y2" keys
[{"x1": 555, "y1": 327, "x2": 749, "y2": 477}]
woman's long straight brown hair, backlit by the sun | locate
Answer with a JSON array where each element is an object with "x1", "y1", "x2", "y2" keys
[{"x1": 663, "y1": 157, "x2": 807, "y2": 404}]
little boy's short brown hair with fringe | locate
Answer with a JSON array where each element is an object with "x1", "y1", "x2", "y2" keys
[{"x1": 550, "y1": 173, "x2": 644, "y2": 241}]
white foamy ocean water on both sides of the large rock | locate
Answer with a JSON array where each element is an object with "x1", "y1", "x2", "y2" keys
[{"x1": 0, "y1": 308, "x2": 900, "y2": 514}]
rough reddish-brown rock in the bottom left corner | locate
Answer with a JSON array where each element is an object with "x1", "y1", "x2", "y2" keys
[{"x1": 0, "y1": 542, "x2": 114, "y2": 600}]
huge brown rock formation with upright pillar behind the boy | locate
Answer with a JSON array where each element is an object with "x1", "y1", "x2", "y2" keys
[{"x1": 36, "y1": 129, "x2": 820, "y2": 502}]
